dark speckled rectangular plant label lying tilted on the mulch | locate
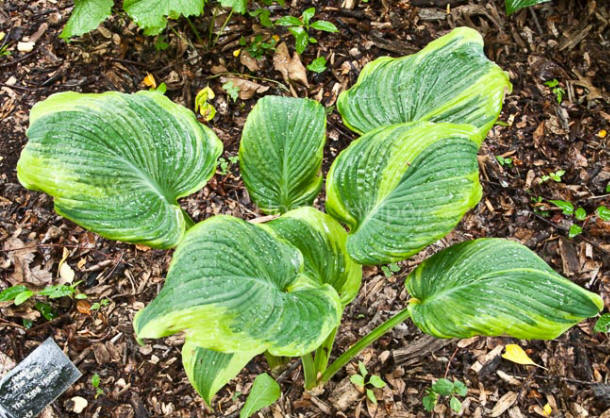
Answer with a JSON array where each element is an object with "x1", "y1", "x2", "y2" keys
[{"x1": 0, "y1": 338, "x2": 81, "y2": 418}]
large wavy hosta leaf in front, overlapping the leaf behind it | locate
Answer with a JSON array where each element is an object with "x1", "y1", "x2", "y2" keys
[{"x1": 134, "y1": 216, "x2": 341, "y2": 356}]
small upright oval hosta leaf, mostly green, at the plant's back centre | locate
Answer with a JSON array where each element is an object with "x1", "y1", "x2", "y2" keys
[{"x1": 239, "y1": 96, "x2": 326, "y2": 213}]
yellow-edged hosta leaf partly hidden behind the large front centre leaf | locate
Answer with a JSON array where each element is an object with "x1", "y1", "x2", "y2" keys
[{"x1": 265, "y1": 207, "x2": 362, "y2": 305}]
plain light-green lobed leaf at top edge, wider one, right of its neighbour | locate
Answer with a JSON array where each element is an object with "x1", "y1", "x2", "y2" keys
[{"x1": 123, "y1": 0, "x2": 205, "y2": 35}]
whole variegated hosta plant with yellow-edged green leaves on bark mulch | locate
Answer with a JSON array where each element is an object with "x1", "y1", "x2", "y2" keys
[{"x1": 19, "y1": 28, "x2": 603, "y2": 412}]
